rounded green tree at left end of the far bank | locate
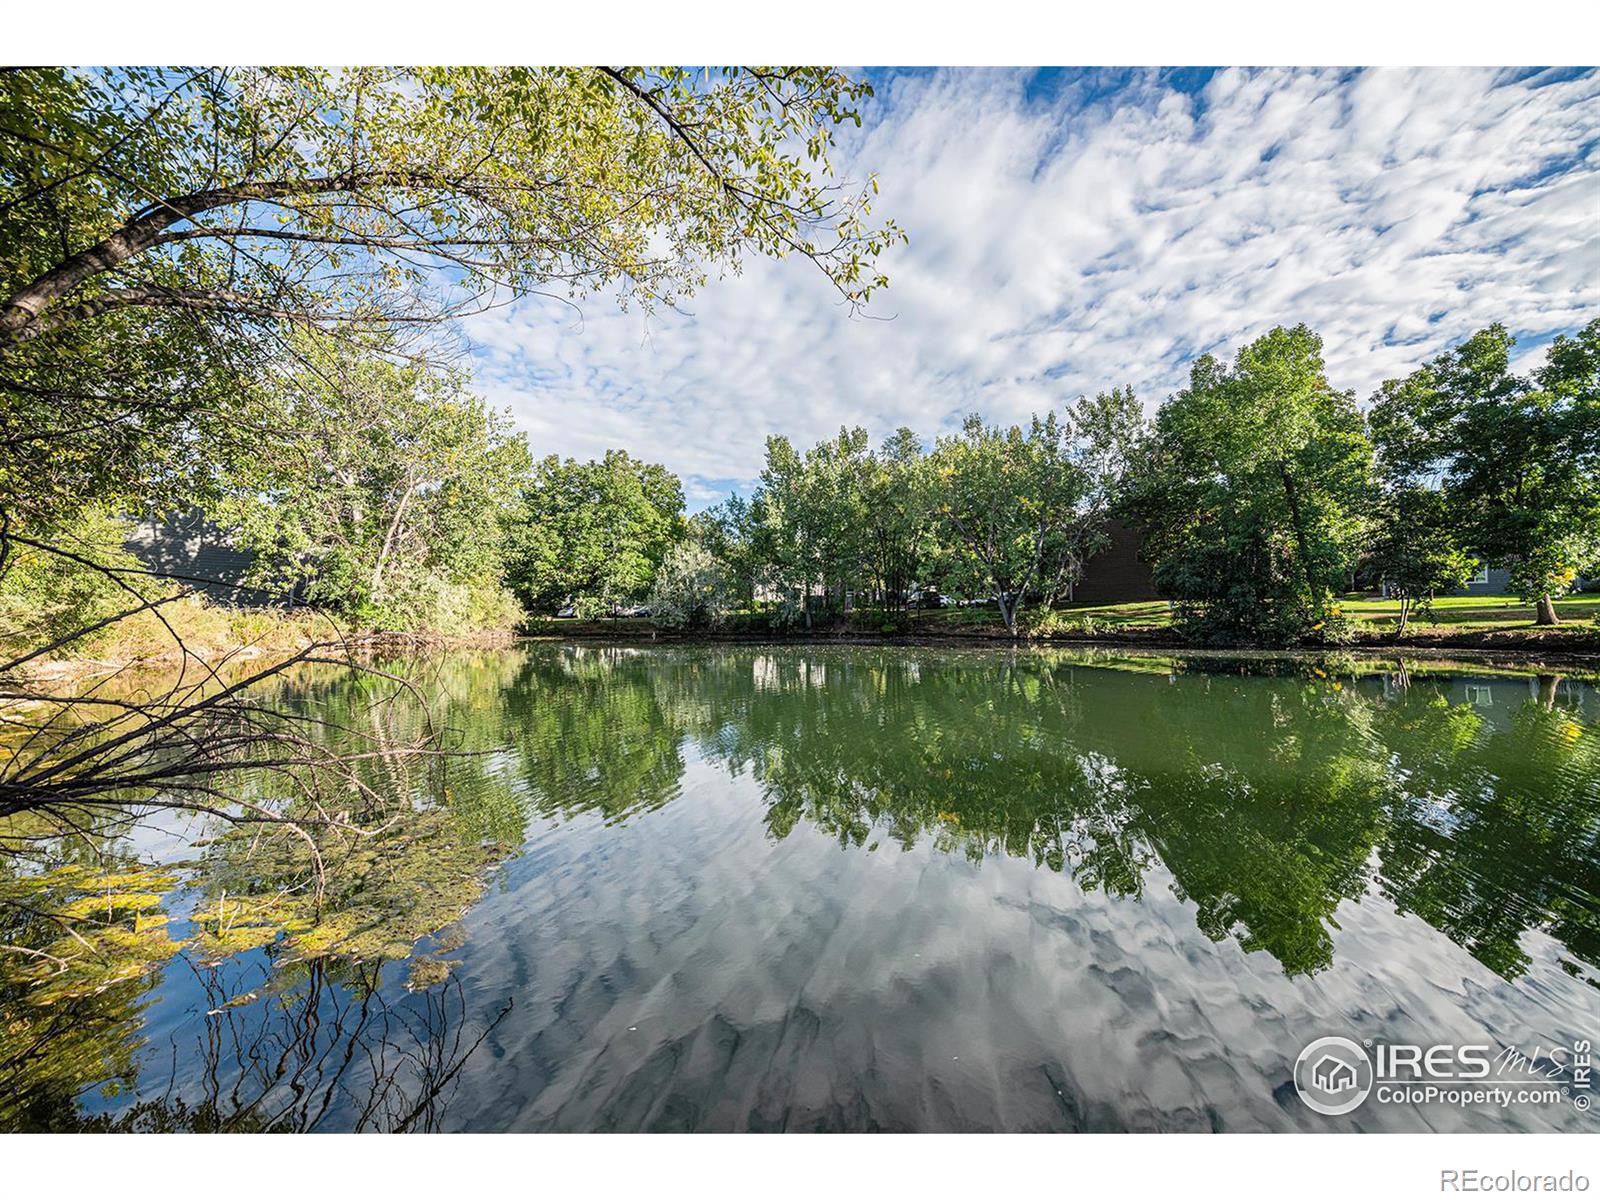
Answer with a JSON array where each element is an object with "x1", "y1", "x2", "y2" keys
[{"x1": 506, "y1": 450, "x2": 683, "y2": 616}]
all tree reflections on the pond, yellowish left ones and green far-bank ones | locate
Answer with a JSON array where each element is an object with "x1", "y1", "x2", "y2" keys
[{"x1": 0, "y1": 646, "x2": 1600, "y2": 1130}]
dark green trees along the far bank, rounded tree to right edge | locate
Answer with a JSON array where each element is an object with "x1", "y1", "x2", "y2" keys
[{"x1": 507, "y1": 322, "x2": 1600, "y2": 642}]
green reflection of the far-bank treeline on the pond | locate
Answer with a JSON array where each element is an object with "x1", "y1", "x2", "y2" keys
[{"x1": 499, "y1": 648, "x2": 1600, "y2": 978}]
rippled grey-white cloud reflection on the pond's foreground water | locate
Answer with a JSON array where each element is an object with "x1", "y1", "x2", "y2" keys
[{"x1": 451, "y1": 739, "x2": 1592, "y2": 1130}]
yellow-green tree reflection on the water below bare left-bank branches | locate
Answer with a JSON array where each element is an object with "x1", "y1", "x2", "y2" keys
[{"x1": 0, "y1": 664, "x2": 525, "y2": 1130}]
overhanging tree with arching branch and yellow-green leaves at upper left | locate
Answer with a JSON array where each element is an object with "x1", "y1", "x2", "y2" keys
[{"x1": 0, "y1": 67, "x2": 901, "y2": 534}]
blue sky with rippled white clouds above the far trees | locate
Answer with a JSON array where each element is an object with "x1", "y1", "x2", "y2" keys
[{"x1": 466, "y1": 69, "x2": 1600, "y2": 509}]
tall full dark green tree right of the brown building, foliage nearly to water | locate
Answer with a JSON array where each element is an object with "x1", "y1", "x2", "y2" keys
[{"x1": 1133, "y1": 325, "x2": 1373, "y2": 638}]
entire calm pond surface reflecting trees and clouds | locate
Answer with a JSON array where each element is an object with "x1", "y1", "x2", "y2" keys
[{"x1": 0, "y1": 643, "x2": 1600, "y2": 1131}]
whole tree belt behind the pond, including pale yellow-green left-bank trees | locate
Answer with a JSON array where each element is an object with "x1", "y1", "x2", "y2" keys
[{"x1": 0, "y1": 322, "x2": 1600, "y2": 642}]
